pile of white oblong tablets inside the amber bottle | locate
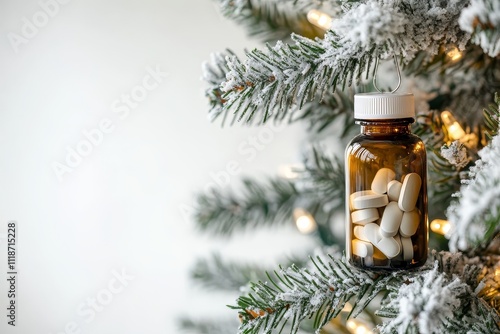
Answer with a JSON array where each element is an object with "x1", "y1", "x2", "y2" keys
[{"x1": 350, "y1": 168, "x2": 422, "y2": 266}]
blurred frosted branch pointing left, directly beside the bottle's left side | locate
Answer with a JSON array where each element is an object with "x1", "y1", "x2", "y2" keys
[{"x1": 194, "y1": 148, "x2": 345, "y2": 239}]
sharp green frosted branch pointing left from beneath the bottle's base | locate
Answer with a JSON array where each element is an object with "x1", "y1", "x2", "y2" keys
[{"x1": 233, "y1": 254, "x2": 393, "y2": 333}]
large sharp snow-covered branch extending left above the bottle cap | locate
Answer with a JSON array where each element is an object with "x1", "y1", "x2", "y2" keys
[{"x1": 217, "y1": 1, "x2": 468, "y2": 122}]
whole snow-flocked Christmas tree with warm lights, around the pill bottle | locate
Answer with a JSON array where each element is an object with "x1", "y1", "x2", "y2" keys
[{"x1": 192, "y1": 0, "x2": 500, "y2": 334}]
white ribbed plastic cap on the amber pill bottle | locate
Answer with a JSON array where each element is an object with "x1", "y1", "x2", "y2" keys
[{"x1": 354, "y1": 93, "x2": 415, "y2": 119}]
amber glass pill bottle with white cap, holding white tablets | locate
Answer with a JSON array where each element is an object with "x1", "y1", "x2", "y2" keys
[{"x1": 345, "y1": 93, "x2": 428, "y2": 270}]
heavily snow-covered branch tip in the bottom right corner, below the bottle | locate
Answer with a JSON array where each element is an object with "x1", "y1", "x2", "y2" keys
[{"x1": 377, "y1": 267, "x2": 500, "y2": 334}]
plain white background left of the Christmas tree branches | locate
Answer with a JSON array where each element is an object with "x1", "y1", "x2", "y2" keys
[{"x1": 0, "y1": 0, "x2": 316, "y2": 334}]
